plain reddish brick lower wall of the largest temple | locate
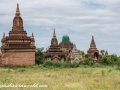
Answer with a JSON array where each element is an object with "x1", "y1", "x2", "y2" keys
[{"x1": 1, "y1": 52, "x2": 35, "y2": 66}]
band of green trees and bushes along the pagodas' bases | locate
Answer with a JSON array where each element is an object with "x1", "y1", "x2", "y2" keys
[{"x1": 35, "y1": 48, "x2": 120, "y2": 70}]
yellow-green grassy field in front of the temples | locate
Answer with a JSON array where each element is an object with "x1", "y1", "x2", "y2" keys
[{"x1": 0, "y1": 65, "x2": 120, "y2": 90}]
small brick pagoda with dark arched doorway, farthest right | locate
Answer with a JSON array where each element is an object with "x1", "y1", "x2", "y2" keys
[{"x1": 86, "y1": 36, "x2": 102, "y2": 62}]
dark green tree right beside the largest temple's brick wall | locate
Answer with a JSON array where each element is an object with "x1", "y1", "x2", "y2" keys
[{"x1": 35, "y1": 47, "x2": 44, "y2": 64}]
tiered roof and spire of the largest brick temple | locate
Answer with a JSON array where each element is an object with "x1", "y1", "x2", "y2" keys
[{"x1": 1, "y1": 4, "x2": 35, "y2": 52}]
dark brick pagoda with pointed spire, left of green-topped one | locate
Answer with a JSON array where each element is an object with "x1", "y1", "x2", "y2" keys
[{"x1": 45, "y1": 29, "x2": 65, "y2": 62}]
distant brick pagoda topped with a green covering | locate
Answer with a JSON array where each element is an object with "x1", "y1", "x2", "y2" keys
[{"x1": 59, "y1": 35, "x2": 73, "y2": 56}]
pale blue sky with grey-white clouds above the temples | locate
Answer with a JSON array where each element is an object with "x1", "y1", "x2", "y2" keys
[{"x1": 0, "y1": 0, "x2": 120, "y2": 56}]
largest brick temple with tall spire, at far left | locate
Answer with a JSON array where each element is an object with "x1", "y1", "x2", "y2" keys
[{"x1": 0, "y1": 4, "x2": 35, "y2": 66}]
